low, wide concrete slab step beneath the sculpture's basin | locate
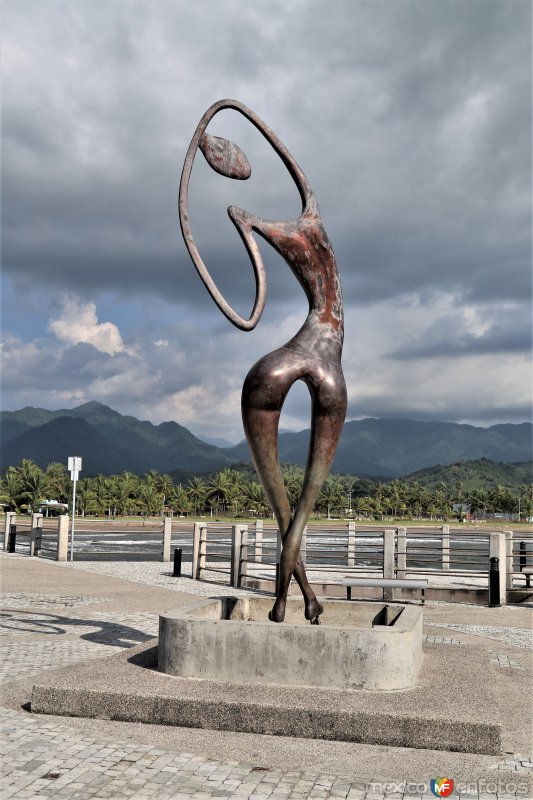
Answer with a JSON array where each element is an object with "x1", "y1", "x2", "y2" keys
[{"x1": 31, "y1": 640, "x2": 501, "y2": 755}]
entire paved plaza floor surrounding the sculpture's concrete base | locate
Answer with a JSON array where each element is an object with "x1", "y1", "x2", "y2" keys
[{"x1": 0, "y1": 553, "x2": 533, "y2": 800}]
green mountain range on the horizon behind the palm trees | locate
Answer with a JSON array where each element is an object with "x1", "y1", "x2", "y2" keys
[{"x1": 0, "y1": 402, "x2": 533, "y2": 479}]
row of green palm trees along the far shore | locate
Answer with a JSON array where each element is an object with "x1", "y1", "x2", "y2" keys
[{"x1": 0, "y1": 459, "x2": 533, "y2": 521}]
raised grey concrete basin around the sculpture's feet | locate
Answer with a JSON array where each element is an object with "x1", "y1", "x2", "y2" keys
[{"x1": 159, "y1": 597, "x2": 422, "y2": 691}]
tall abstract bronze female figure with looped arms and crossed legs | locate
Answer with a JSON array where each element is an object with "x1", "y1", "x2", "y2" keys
[{"x1": 179, "y1": 100, "x2": 346, "y2": 625}]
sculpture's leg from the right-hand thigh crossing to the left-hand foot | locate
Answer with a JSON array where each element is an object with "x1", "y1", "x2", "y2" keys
[{"x1": 270, "y1": 376, "x2": 346, "y2": 624}]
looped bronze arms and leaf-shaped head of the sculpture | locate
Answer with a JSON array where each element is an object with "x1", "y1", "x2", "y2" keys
[{"x1": 179, "y1": 100, "x2": 318, "y2": 331}]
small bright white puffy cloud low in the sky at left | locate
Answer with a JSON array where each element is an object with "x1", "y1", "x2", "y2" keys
[{"x1": 48, "y1": 295, "x2": 134, "y2": 356}]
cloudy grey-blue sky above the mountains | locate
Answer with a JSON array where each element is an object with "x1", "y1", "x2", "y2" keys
[{"x1": 2, "y1": 0, "x2": 532, "y2": 441}]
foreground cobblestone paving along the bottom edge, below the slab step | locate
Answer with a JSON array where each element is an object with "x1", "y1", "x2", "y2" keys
[{"x1": 0, "y1": 711, "x2": 533, "y2": 800}]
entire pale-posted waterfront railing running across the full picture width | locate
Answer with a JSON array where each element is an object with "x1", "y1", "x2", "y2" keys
[{"x1": 4, "y1": 512, "x2": 533, "y2": 590}]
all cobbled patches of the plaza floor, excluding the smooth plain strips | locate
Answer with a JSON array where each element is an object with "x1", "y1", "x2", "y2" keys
[{"x1": 0, "y1": 562, "x2": 533, "y2": 800}]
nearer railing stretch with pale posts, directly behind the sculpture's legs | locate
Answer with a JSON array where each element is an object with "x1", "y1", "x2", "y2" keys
[{"x1": 188, "y1": 522, "x2": 533, "y2": 596}]
